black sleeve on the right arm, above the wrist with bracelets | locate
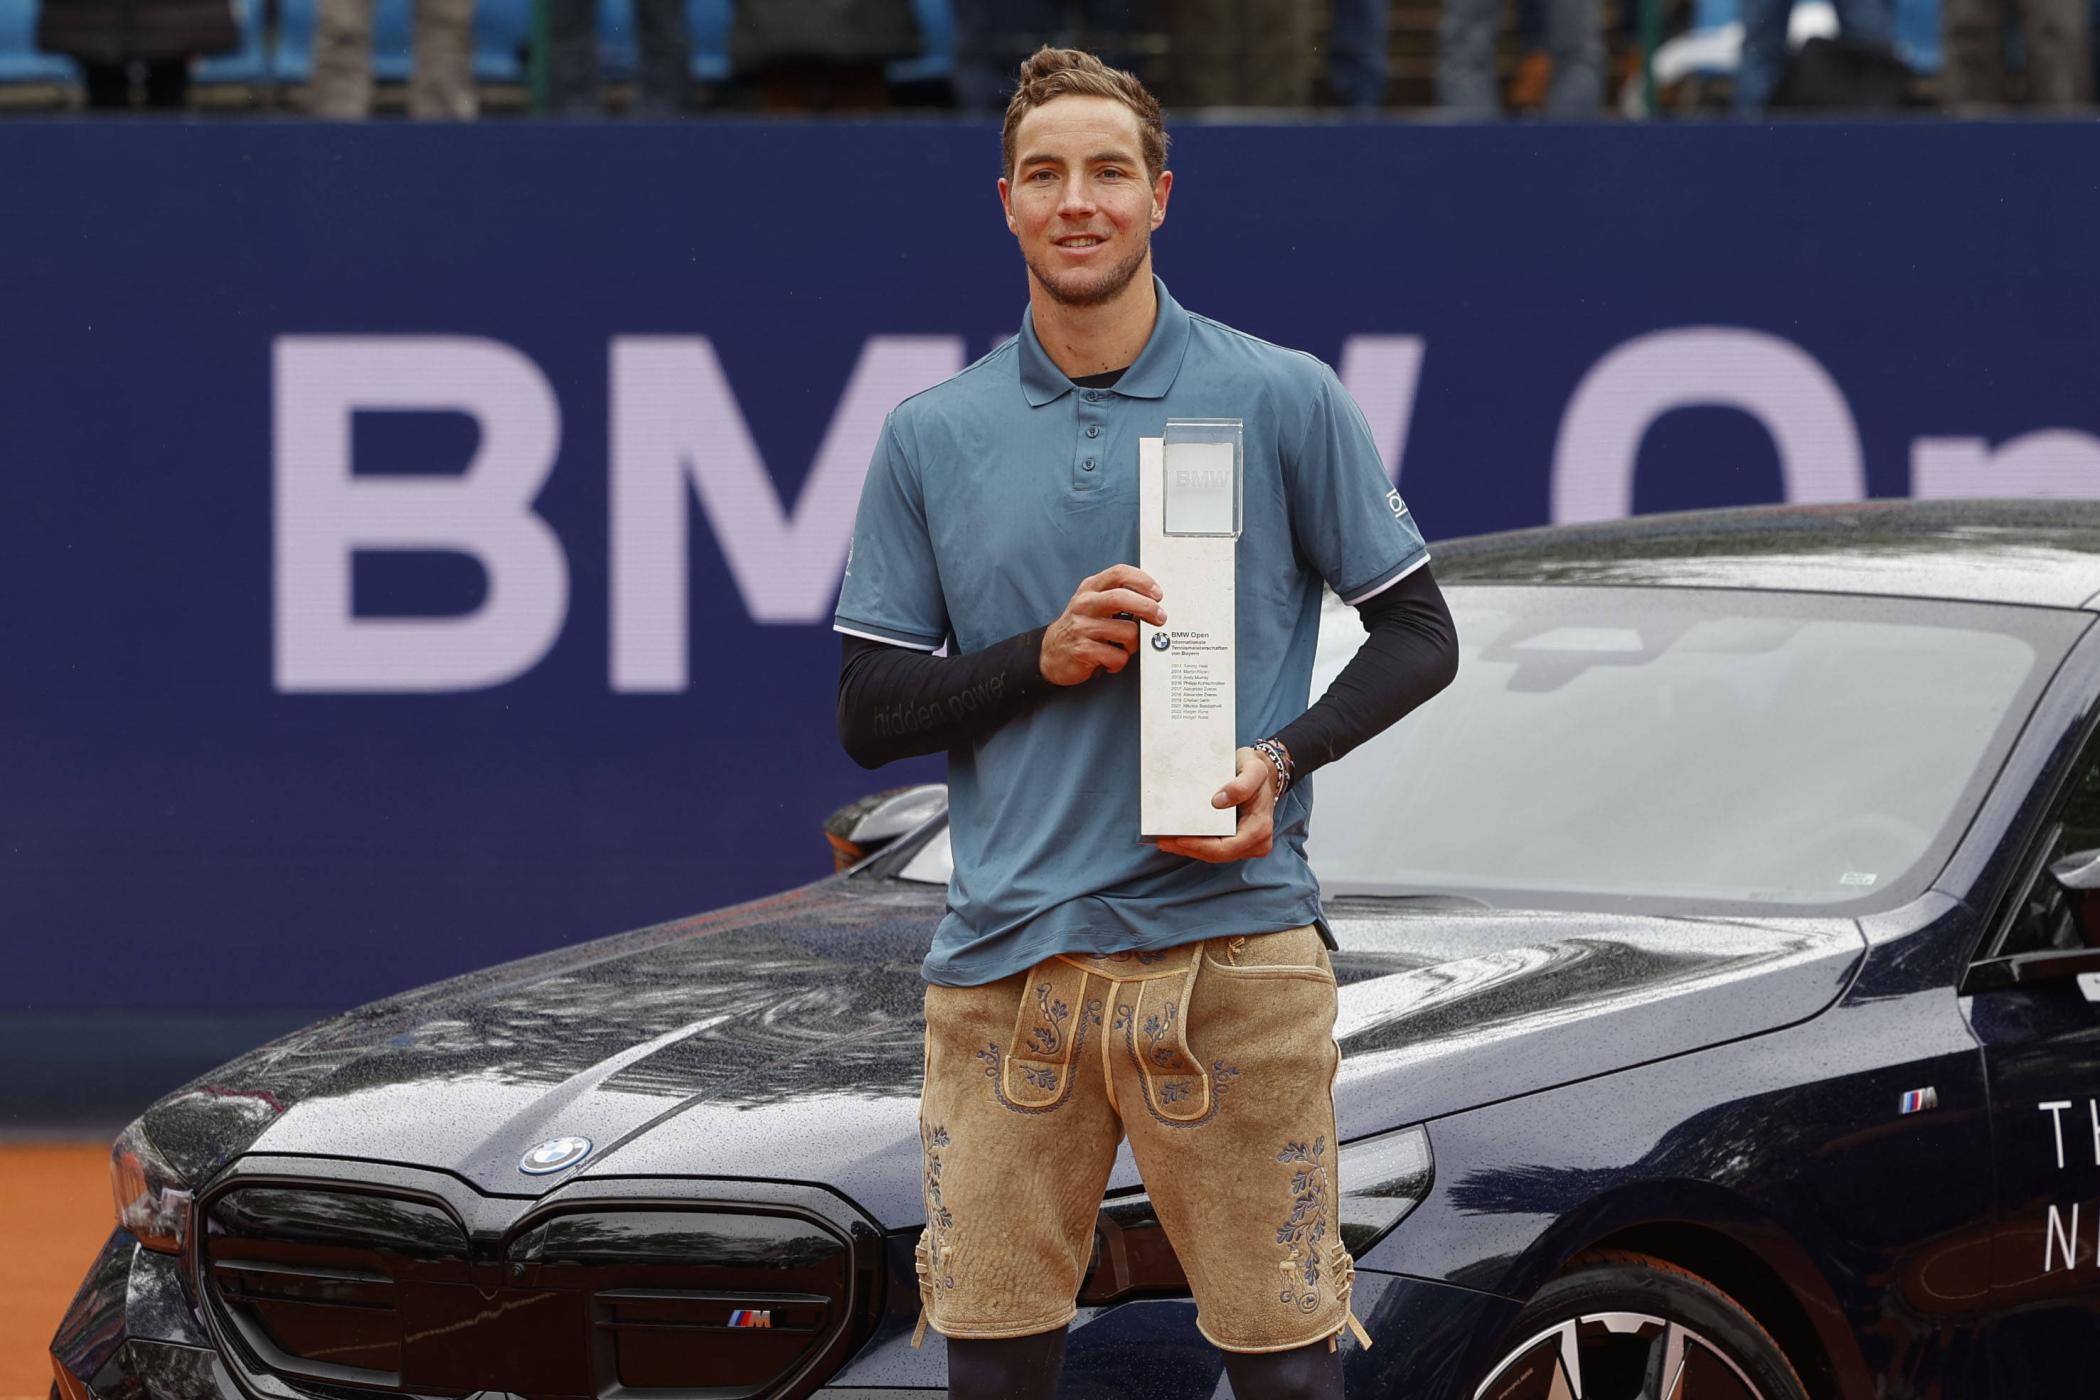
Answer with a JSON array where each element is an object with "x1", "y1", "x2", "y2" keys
[{"x1": 1277, "y1": 565, "x2": 1457, "y2": 779}]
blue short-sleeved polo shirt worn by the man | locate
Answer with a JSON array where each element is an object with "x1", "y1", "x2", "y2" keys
[{"x1": 834, "y1": 277, "x2": 1428, "y2": 987}]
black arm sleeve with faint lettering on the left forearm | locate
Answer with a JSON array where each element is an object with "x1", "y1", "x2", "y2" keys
[{"x1": 838, "y1": 628, "x2": 1050, "y2": 768}]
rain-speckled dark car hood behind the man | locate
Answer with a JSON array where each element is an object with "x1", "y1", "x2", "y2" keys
[{"x1": 145, "y1": 877, "x2": 1867, "y2": 1226}]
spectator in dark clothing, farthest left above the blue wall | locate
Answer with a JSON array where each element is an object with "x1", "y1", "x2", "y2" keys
[{"x1": 36, "y1": 0, "x2": 239, "y2": 111}]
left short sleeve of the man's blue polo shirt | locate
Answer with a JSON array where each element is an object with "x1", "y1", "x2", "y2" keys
[{"x1": 832, "y1": 413, "x2": 947, "y2": 651}]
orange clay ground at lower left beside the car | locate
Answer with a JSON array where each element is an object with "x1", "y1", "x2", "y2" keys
[{"x1": 0, "y1": 1142, "x2": 111, "y2": 1400}]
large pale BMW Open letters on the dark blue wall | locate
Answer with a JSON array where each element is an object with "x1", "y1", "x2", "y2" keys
[{"x1": 273, "y1": 325, "x2": 2100, "y2": 693}]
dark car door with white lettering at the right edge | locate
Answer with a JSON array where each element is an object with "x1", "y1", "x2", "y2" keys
[{"x1": 1964, "y1": 733, "x2": 2100, "y2": 1396}]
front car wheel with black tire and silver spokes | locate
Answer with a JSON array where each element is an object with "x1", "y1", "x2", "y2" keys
[{"x1": 1472, "y1": 1249, "x2": 1808, "y2": 1400}]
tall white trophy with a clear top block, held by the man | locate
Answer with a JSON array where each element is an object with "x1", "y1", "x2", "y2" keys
[{"x1": 1138, "y1": 418, "x2": 1245, "y2": 837}]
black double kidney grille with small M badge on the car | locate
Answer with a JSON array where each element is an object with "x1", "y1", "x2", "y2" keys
[{"x1": 202, "y1": 1184, "x2": 857, "y2": 1400}]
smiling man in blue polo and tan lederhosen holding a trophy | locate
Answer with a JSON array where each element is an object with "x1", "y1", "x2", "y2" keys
[{"x1": 836, "y1": 48, "x2": 1455, "y2": 1398}]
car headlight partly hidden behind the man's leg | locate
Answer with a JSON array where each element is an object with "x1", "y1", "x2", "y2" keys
[{"x1": 1079, "y1": 1123, "x2": 1436, "y2": 1306}]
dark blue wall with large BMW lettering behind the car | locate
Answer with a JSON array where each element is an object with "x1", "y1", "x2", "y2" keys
[{"x1": 0, "y1": 122, "x2": 2100, "y2": 1028}]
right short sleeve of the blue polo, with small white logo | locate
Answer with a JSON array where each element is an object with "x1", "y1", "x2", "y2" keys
[{"x1": 1283, "y1": 365, "x2": 1430, "y2": 602}]
